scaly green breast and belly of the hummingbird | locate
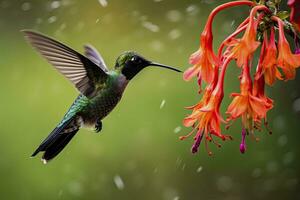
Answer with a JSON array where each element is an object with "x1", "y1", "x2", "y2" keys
[{"x1": 81, "y1": 75, "x2": 128, "y2": 126}]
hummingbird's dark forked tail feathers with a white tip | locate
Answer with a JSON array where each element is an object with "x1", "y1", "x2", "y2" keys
[{"x1": 31, "y1": 116, "x2": 79, "y2": 164}]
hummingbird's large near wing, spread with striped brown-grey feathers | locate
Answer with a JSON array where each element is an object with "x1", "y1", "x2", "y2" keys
[{"x1": 23, "y1": 30, "x2": 108, "y2": 97}]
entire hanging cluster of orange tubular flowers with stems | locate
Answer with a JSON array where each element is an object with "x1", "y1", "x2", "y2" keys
[{"x1": 180, "y1": 0, "x2": 300, "y2": 155}]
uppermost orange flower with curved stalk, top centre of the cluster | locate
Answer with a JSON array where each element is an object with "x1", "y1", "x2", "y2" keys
[{"x1": 229, "y1": 6, "x2": 266, "y2": 67}]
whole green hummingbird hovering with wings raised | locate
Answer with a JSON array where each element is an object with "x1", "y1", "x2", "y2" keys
[{"x1": 22, "y1": 30, "x2": 181, "y2": 164}]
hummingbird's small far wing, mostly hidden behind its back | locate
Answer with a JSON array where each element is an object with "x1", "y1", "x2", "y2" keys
[{"x1": 84, "y1": 44, "x2": 109, "y2": 73}]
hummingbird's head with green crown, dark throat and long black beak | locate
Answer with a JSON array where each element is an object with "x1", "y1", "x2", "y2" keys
[{"x1": 115, "y1": 51, "x2": 182, "y2": 80}]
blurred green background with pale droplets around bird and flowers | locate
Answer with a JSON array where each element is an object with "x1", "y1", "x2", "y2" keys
[{"x1": 0, "y1": 0, "x2": 300, "y2": 200}]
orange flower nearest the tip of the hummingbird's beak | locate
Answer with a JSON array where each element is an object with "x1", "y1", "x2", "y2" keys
[{"x1": 183, "y1": 25, "x2": 217, "y2": 83}]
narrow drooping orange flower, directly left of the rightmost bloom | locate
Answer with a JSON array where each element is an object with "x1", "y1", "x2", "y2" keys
[{"x1": 261, "y1": 27, "x2": 282, "y2": 85}]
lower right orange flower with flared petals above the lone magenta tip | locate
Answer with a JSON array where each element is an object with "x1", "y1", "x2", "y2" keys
[{"x1": 226, "y1": 63, "x2": 267, "y2": 130}]
